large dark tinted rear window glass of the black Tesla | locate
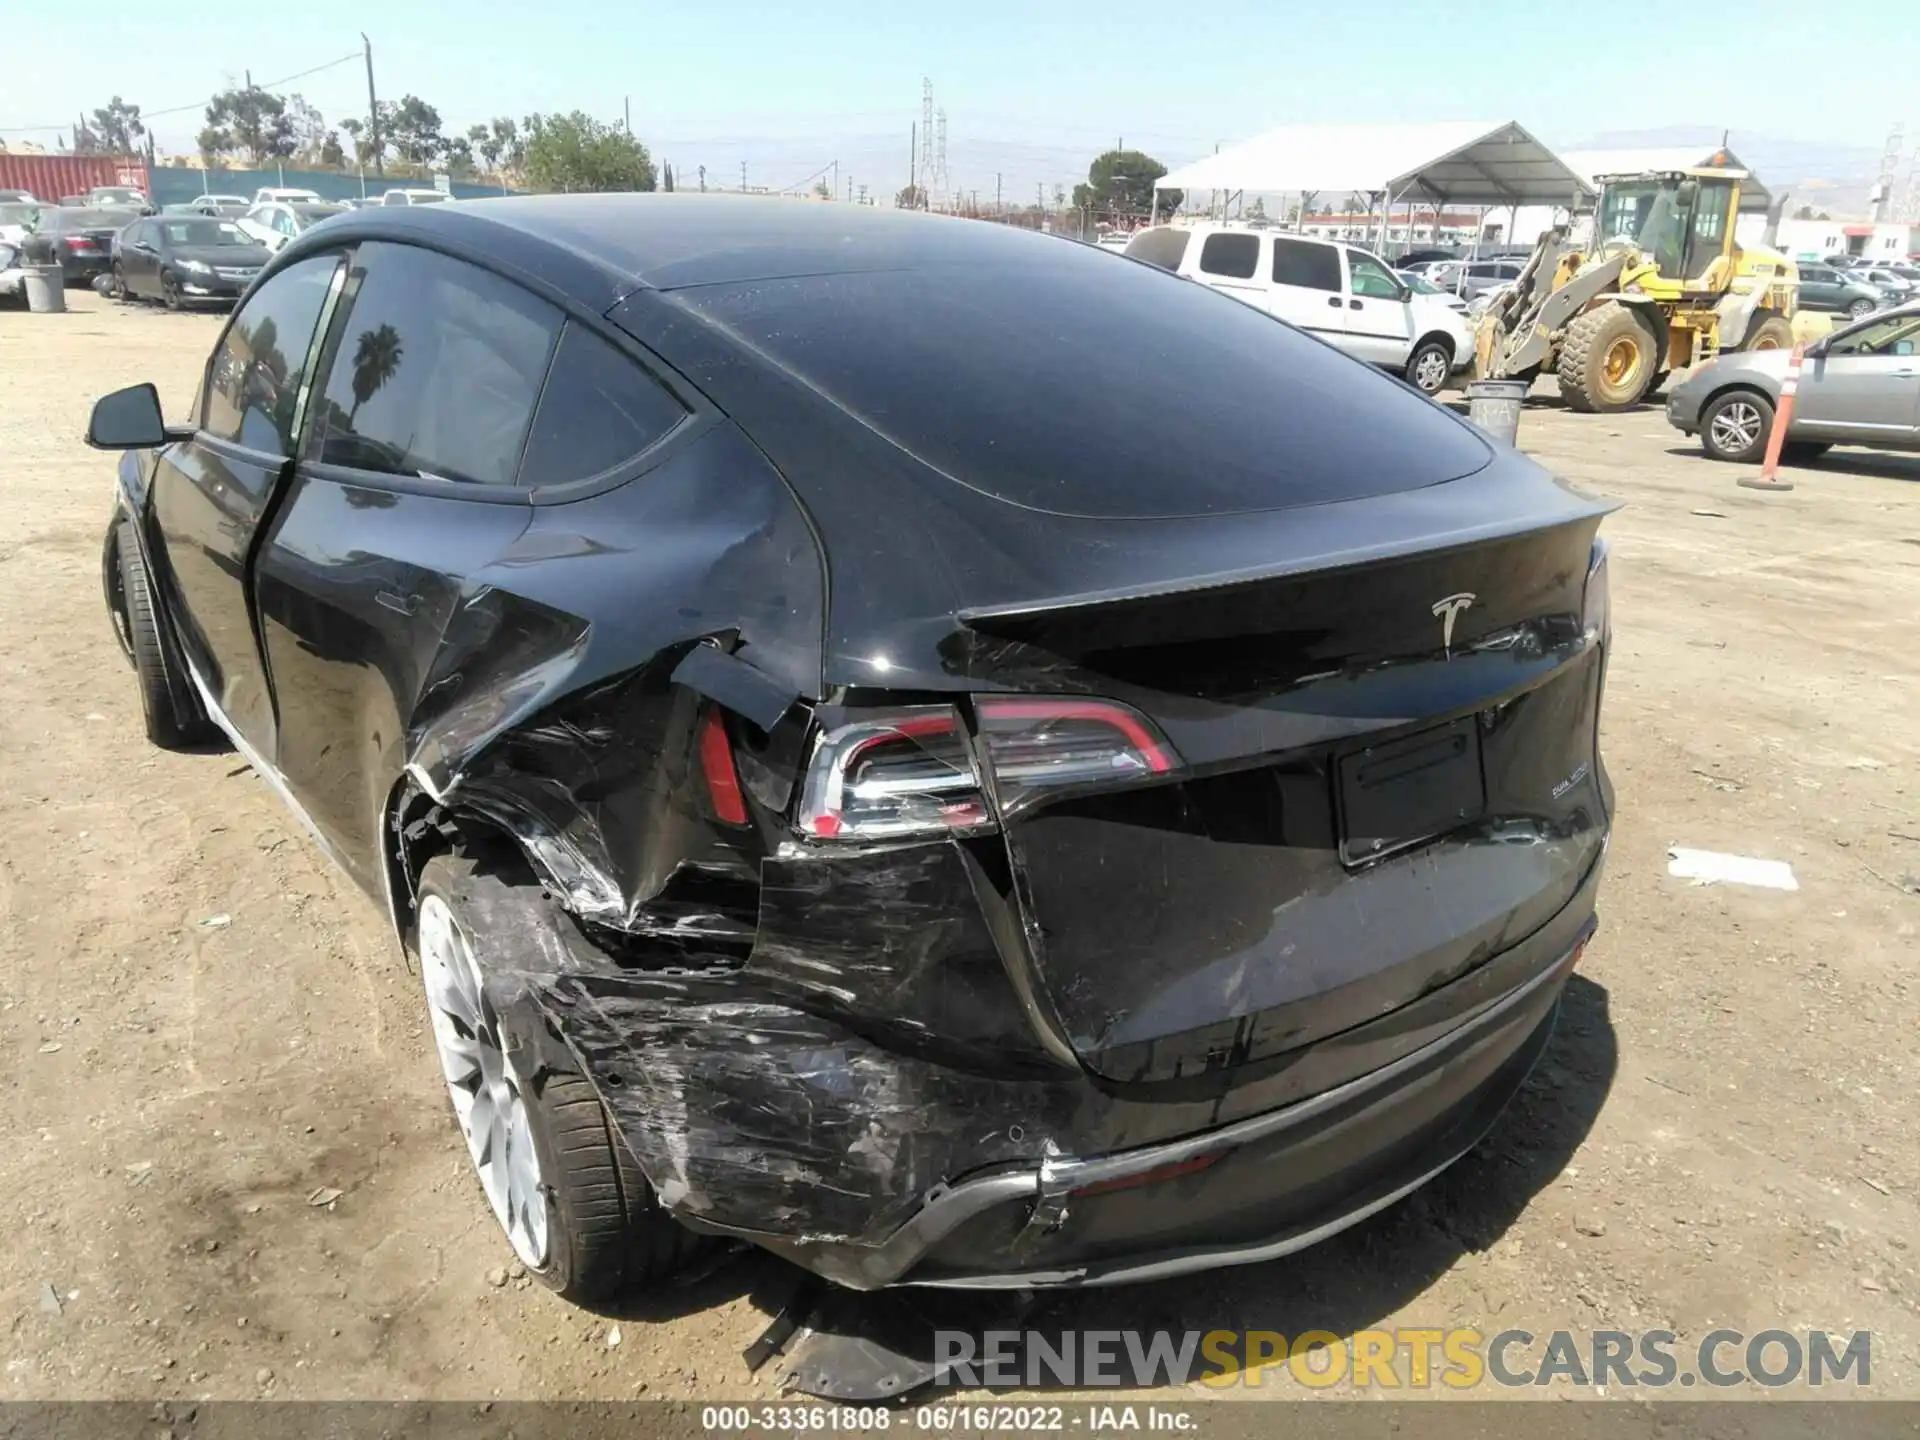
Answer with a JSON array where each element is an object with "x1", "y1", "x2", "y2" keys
[{"x1": 683, "y1": 257, "x2": 1492, "y2": 518}]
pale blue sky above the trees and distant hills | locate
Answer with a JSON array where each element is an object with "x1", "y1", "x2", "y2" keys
[{"x1": 0, "y1": 0, "x2": 1920, "y2": 200}]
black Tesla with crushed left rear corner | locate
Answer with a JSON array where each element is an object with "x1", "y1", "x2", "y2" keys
[{"x1": 88, "y1": 196, "x2": 1613, "y2": 1300}]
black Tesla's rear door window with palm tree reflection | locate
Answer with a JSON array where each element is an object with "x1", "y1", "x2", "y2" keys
[{"x1": 309, "y1": 246, "x2": 561, "y2": 486}]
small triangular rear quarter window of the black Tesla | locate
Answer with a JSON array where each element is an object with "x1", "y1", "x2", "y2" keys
[{"x1": 520, "y1": 324, "x2": 687, "y2": 490}]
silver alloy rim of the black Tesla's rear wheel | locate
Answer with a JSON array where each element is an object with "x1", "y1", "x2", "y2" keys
[{"x1": 420, "y1": 895, "x2": 547, "y2": 1269}]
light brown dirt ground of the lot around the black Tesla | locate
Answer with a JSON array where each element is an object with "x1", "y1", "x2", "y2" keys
[{"x1": 0, "y1": 292, "x2": 1920, "y2": 1400}]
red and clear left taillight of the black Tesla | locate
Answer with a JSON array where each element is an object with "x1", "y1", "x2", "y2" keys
[{"x1": 797, "y1": 697, "x2": 1181, "y2": 839}]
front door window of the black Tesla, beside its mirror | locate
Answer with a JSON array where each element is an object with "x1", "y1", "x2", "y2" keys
[{"x1": 200, "y1": 255, "x2": 340, "y2": 455}]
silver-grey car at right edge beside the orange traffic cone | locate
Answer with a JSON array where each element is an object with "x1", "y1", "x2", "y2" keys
[{"x1": 1667, "y1": 301, "x2": 1920, "y2": 463}]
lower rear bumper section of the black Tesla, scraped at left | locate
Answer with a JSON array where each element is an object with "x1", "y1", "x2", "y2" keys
[{"x1": 770, "y1": 920, "x2": 1594, "y2": 1290}]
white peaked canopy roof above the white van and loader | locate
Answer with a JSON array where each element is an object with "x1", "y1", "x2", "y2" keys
[{"x1": 1154, "y1": 121, "x2": 1592, "y2": 205}]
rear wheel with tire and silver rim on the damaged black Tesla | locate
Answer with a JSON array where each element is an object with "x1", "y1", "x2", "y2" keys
[{"x1": 413, "y1": 852, "x2": 710, "y2": 1304}]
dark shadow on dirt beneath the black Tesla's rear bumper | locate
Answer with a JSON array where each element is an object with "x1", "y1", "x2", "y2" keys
[{"x1": 725, "y1": 975, "x2": 1619, "y2": 1400}]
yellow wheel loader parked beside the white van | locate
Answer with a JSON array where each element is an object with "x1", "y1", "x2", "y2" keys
[{"x1": 1475, "y1": 167, "x2": 1799, "y2": 411}]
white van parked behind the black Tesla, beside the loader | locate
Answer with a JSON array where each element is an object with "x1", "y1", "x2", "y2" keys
[{"x1": 1127, "y1": 225, "x2": 1473, "y2": 396}]
